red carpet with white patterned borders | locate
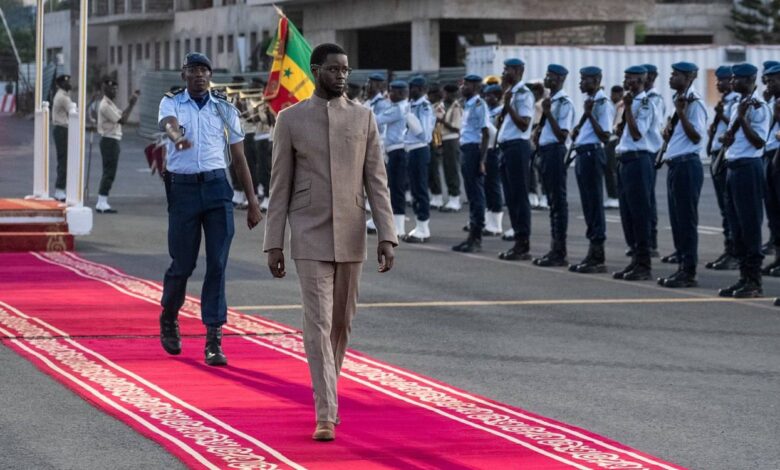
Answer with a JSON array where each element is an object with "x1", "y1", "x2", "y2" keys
[{"x1": 0, "y1": 253, "x2": 681, "y2": 469}]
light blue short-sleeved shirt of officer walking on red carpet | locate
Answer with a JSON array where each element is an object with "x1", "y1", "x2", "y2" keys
[{"x1": 157, "y1": 90, "x2": 244, "y2": 174}]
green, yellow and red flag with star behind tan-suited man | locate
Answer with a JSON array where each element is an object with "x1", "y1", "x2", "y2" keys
[{"x1": 263, "y1": 11, "x2": 314, "y2": 114}]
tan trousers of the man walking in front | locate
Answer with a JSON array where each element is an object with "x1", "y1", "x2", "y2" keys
[{"x1": 295, "y1": 259, "x2": 363, "y2": 423}]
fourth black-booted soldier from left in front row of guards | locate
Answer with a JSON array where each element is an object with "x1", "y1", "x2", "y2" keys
[{"x1": 569, "y1": 67, "x2": 615, "y2": 274}]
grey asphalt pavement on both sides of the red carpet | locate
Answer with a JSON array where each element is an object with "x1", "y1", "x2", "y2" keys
[{"x1": 0, "y1": 114, "x2": 780, "y2": 470}]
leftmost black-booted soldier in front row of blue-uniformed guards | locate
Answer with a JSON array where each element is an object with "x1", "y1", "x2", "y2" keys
[{"x1": 452, "y1": 75, "x2": 490, "y2": 253}]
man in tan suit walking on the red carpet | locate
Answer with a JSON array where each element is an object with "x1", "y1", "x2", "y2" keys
[{"x1": 263, "y1": 44, "x2": 398, "y2": 441}]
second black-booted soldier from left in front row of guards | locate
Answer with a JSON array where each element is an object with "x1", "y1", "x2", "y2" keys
[{"x1": 497, "y1": 58, "x2": 534, "y2": 261}]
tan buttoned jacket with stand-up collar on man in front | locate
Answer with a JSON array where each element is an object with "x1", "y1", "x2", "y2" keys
[{"x1": 263, "y1": 95, "x2": 398, "y2": 263}]
